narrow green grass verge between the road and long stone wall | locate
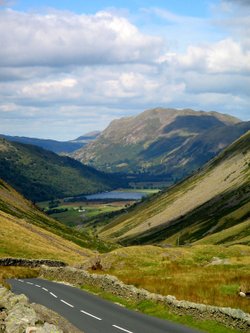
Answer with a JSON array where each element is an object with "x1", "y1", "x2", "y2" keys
[{"x1": 81, "y1": 285, "x2": 242, "y2": 333}]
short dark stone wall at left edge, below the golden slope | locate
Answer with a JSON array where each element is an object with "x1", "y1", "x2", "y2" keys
[{"x1": 0, "y1": 258, "x2": 66, "y2": 267}]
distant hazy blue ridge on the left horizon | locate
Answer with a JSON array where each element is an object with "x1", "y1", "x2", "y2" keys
[{"x1": 0, "y1": 131, "x2": 100, "y2": 154}]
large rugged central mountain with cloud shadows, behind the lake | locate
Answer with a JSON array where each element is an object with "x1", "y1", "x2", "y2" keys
[{"x1": 72, "y1": 108, "x2": 247, "y2": 183}]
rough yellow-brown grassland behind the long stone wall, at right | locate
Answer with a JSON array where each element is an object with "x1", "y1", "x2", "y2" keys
[{"x1": 93, "y1": 246, "x2": 250, "y2": 313}]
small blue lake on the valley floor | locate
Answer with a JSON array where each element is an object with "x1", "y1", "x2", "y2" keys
[{"x1": 85, "y1": 191, "x2": 147, "y2": 200}]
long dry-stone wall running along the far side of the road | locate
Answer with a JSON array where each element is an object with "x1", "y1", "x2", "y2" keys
[{"x1": 40, "y1": 266, "x2": 250, "y2": 333}]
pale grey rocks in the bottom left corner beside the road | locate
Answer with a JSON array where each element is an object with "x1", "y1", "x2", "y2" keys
[{"x1": 0, "y1": 286, "x2": 81, "y2": 333}]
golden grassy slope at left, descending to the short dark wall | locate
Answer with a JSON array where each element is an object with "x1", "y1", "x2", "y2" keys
[{"x1": 0, "y1": 180, "x2": 92, "y2": 263}]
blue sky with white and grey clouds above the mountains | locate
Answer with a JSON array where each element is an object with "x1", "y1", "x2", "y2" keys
[{"x1": 0, "y1": 0, "x2": 250, "y2": 140}]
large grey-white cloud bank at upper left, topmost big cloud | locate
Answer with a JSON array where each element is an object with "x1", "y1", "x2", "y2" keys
[{"x1": 0, "y1": 10, "x2": 162, "y2": 67}]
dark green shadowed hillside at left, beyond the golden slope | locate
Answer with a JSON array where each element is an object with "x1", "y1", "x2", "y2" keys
[{"x1": 0, "y1": 139, "x2": 120, "y2": 201}]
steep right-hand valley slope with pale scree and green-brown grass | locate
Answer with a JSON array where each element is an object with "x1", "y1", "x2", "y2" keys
[{"x1": 100, "y1": 131, "x2": 250, "y2": 245}]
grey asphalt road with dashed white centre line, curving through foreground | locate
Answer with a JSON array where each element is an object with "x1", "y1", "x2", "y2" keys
[{"x1": 8, "y1": 279, "x2": 202, "y2": 333}]
